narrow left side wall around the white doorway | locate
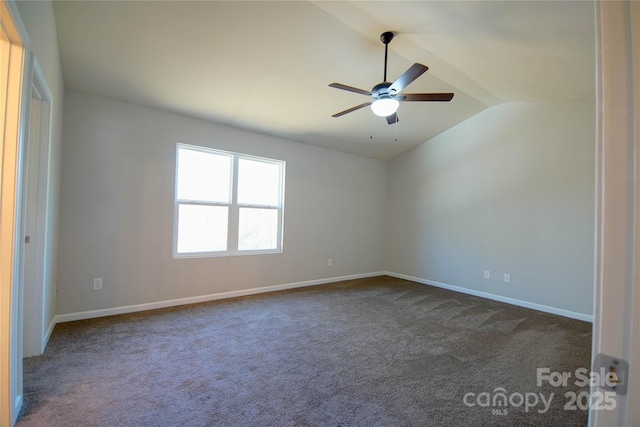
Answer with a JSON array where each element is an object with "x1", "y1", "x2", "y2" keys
[{"x1": 16, "y1": 1, "x2": 64, "y2": 346}]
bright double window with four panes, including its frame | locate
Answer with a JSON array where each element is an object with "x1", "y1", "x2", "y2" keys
[{"x1": 173, "y1": 144, "x2": 285, "y2": 258}]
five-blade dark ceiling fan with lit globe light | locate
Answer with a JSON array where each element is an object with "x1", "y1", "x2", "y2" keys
[{"x1": 329, "y1": 31, "x2": 453, "y2": 125}]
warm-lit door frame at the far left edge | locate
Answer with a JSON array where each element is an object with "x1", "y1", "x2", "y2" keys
[{"x1": 0, "y1": 0, "x2": 31, "y2": 426}]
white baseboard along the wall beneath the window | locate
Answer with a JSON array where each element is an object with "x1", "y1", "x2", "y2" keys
[{"x1": 49, "y1": 271, "x2": 385, "y2": 324}]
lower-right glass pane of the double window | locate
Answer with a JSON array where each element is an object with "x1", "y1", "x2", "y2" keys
[{"x1": 238, "y1": 208, "x2": 278, "y2": 251}]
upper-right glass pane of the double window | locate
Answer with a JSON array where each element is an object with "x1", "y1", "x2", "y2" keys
[{"x1": 238, "y1": 158, "x2": 280, "y2": 206}]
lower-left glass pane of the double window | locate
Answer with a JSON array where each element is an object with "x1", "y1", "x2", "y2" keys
[{"x1": 177, "y1": 205, "x2": 229, "y2": 253}]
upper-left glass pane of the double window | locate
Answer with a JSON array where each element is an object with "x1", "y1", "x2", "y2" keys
[{"x1": 176, "y1": 148, "x2": 231, "y2": 203}]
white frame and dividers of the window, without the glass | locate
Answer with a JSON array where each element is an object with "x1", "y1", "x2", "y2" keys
[{"x1": 173, "y1": 142, "x2": 286, "y2": 258}]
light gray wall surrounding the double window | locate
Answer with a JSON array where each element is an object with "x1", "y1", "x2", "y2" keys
[{"x1": 57, "y1": 91, "x2": 388, "y2": 314}]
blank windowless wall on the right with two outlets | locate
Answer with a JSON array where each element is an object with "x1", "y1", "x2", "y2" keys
[{"x1": 386, "y1": 103, "x2": 595, "y2": 316}]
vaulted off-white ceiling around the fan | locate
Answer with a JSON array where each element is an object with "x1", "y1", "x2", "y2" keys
[{"x1": 54, "y1": 0, "x2": 595, "y2": 160}]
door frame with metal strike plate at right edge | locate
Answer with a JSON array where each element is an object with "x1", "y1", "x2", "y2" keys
[{"x1": 589, "y1": 0, "x2": 640, "y2": 427}]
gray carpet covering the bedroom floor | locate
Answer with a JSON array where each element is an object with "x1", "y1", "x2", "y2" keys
[{"x1": 18, "y1": 276, "x2": 591, "y2": 427}]
